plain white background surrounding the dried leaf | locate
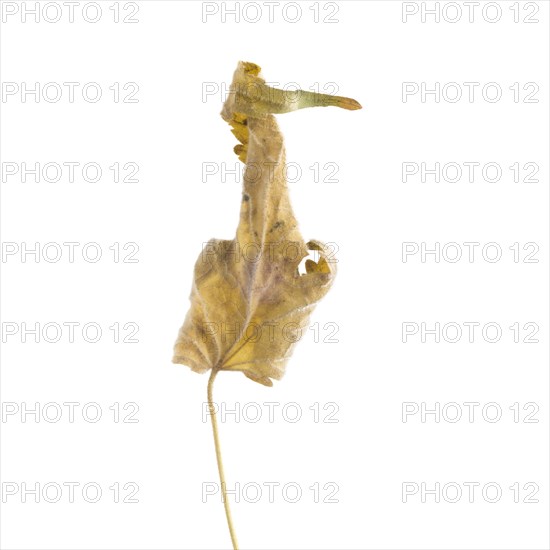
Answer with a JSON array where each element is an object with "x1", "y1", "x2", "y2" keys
[{"x1": 0, "y1": 1, "x2": 549, "y2": 550}]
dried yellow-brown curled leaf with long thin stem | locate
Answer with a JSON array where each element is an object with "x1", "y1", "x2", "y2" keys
[{"x1": 173, "y1": 62, "x2": 361, "y2": 548}]
